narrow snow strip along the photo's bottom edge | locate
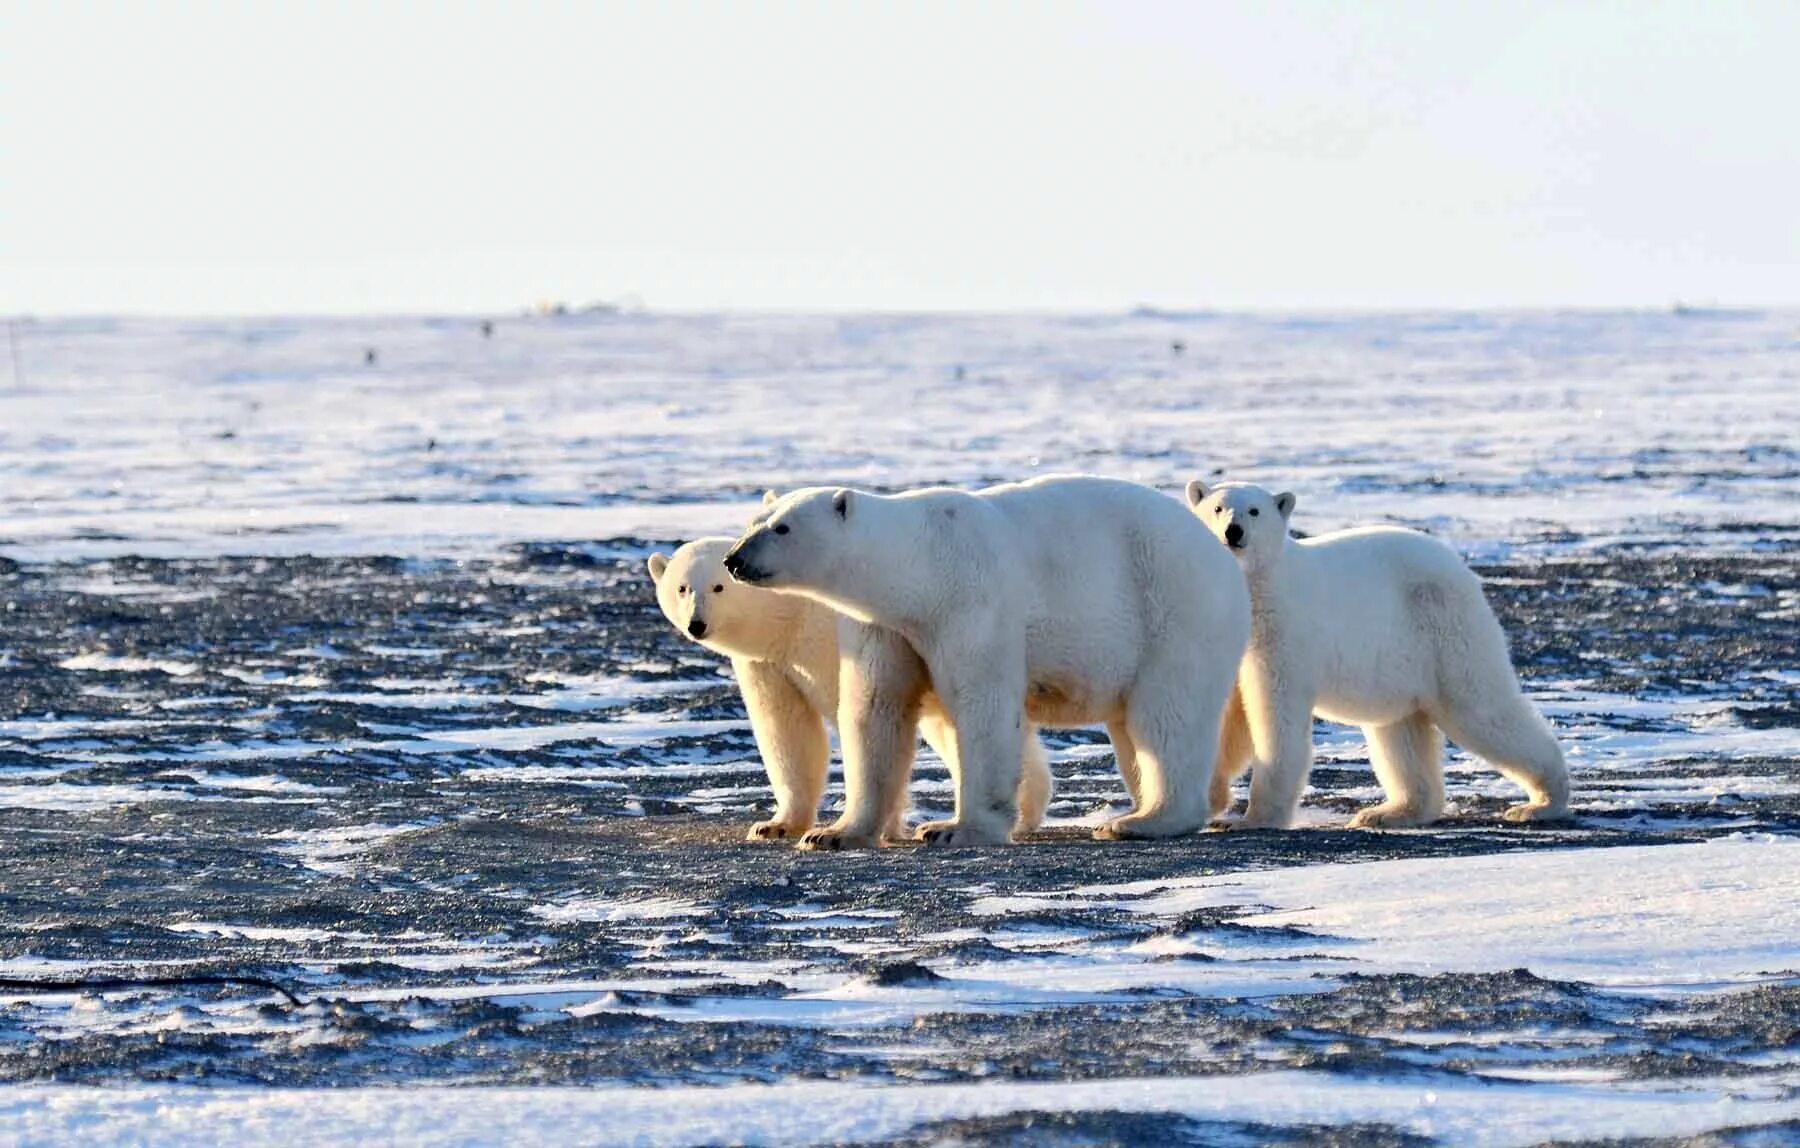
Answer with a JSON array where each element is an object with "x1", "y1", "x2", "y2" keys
[{"x1": 0, "y1": 1071, "x2": 1800, "y2": 1148}]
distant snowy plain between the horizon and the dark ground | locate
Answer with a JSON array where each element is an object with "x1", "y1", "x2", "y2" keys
[{"x1": 0, "y1": 313, "x2": 1800, "y2": 561}]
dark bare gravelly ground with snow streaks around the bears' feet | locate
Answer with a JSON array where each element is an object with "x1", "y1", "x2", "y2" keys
[{"x1": 0, "y1": 540, "x2": 1800, "y2": 1144}]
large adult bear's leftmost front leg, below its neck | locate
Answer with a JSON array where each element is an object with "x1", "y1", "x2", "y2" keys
[{"x1": 799, "y1": 617, "x2": 927, "y2": 849}]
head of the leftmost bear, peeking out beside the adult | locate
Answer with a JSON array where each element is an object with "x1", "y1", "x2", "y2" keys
[{"x1": 644, "y1": 538, "x2": 790, "y2": 659}]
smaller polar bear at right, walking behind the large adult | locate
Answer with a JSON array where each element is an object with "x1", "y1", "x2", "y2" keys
[{"x1": 1188, "y1": 480, "x2": 1570, "y2": 830}]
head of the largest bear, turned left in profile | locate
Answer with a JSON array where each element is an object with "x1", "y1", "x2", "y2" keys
[{"x1": 725, "y1": 486, "x2": 866, "y2": 590}]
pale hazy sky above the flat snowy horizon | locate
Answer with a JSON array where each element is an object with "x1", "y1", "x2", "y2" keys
[{"x1": 0, "y1": 0, "x2": 1800, "y2": 313}]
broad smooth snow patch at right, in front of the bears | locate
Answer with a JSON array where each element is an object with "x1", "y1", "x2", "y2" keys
[{"x1": 972, "y1": 833, "x2": 1800, "y2": 990}]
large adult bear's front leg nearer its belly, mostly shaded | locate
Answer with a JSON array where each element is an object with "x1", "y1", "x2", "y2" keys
[{"x1": 918, "y1": 626, "x2": 1026, "y2": 846}]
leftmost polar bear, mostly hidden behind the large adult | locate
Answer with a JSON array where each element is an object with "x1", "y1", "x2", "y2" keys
[{"x1": 648, "y1": 532, "x2": 1053, "y2": 840}]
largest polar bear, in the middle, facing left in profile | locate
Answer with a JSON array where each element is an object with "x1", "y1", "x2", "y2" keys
[{"x1": 725, "y1": 477, "x2": 1249, "y2": 849}]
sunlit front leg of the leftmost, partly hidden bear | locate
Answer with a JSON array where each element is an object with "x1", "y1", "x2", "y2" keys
[{"x1": 731, "y1": 659, "x2": 832, "y2": 840}]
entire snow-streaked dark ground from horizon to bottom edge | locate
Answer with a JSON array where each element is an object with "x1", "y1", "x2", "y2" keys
[{"x1": 0, "y1": 315, "x2": 1800, "y2": 1144}]
